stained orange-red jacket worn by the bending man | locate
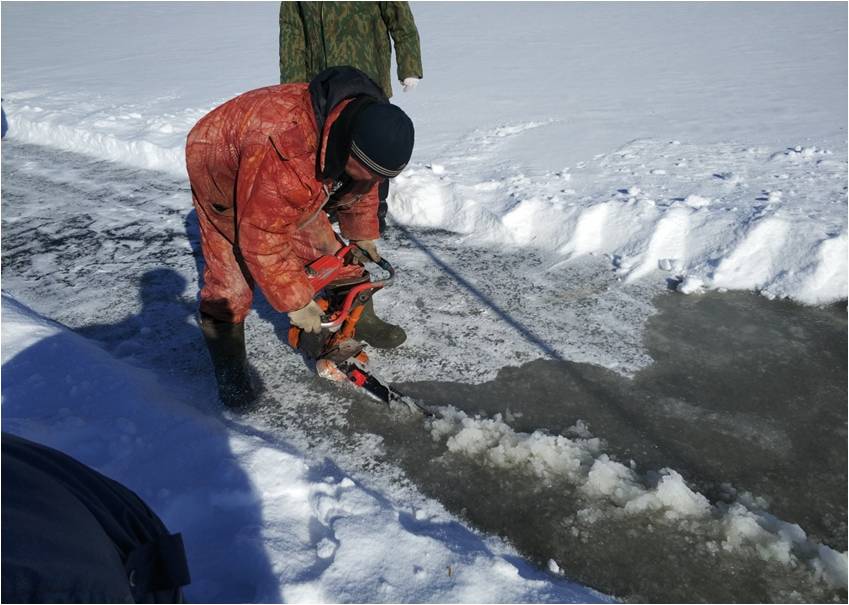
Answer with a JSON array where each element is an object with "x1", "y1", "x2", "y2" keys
[{"x1": 186, "y1": 84, "x2": 380, "y2": 310}]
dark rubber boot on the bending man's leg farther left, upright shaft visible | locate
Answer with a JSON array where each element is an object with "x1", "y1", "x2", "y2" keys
[{"x1": 198, "y1": 313, "x2": 257, "y2": 408}]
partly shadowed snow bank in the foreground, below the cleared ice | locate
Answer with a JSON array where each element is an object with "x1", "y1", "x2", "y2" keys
[{"x1": 2, "y1": 294, "x2": 604, "y2": 603}]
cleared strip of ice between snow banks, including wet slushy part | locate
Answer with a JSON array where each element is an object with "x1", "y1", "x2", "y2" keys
[{"x1": 3, "y1": 142, "x2": 846, "y2": 602}]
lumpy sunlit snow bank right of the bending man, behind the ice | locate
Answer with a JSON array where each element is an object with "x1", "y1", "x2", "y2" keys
[{"x1": 390, "y1": 139, "x2": 849, "y2": 304}]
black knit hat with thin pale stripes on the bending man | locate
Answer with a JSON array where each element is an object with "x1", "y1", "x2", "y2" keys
[{"x1": 351, "y1": 103, "x2": 415, "y2": 178}]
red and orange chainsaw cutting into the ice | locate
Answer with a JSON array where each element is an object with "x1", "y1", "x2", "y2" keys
[{"x1": 288, "y1": 244, "x2": 432, "y2": 416}]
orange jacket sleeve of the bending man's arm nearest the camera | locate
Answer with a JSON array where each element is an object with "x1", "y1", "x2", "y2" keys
[{"x1": 236, "y1": 144, "x2": 313, "y2": 313}]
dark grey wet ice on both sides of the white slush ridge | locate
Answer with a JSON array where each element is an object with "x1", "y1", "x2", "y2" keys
[{"x1": 342, "y1": 293, "x2": 847, "y2": 602}]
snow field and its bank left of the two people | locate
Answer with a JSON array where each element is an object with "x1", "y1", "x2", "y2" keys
[{"x1": 2, "y1": 2, "x2": 279, "y2": 176}]
